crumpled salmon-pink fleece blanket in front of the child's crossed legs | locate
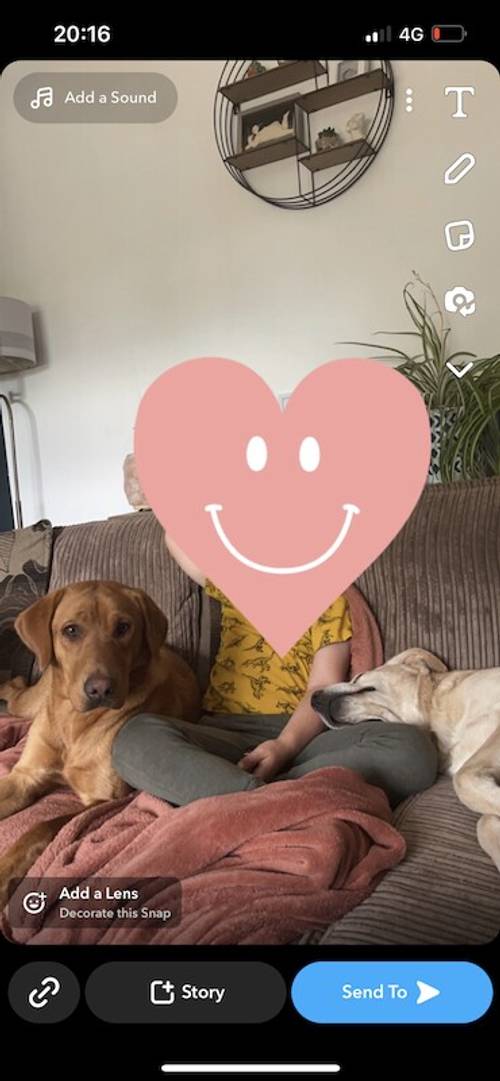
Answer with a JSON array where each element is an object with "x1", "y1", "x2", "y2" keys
[{"x1": 0, "y1": 718, "x2": 405, "y2": 945}]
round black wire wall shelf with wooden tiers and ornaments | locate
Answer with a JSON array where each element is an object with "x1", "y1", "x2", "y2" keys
[{"x1": 214, "y1": 59, "x2": 394, "y2": 210}]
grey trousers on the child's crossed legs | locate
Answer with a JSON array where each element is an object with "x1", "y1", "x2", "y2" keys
[{"x1": 112, "y1": 713, "x2": 437, "y2": 806}]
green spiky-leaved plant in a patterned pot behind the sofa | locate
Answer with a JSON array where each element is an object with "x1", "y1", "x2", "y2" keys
[{"x1": 344, "y1": 270, "x2": 500, "y2": 482}]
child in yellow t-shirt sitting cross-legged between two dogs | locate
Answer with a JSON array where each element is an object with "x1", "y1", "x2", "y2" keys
[{"x1": 112, "y1": 537, "x2": 437, "y2": 806}]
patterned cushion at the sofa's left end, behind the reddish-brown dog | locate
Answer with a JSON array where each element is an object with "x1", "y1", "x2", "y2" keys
[{"x1": 0, "y1": 519, "x2": 53, "y2": 681}]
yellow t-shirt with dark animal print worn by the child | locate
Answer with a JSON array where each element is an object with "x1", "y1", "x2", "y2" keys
[{"x1": 203, "y1": 582, "x2": 352, "y2": 715}]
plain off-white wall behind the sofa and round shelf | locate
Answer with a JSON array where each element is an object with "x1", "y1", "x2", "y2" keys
[{"x1": 0, "y1": 61, "x2": 500, "y2": 524}]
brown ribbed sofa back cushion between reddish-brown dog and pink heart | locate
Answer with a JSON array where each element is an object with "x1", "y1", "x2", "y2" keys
[{"x1": 50, "y1": 510, "x2": 200, "y2": 668}]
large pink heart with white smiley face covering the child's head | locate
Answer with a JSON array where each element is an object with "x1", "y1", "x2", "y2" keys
[{"x1": 135, "y1": 357, "x2": 430, "y2": 656}]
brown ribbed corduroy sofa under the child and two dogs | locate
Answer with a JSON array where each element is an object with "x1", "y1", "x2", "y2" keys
[{"x1": 19, "y1": 480, "x2": 500, "y2": 945}]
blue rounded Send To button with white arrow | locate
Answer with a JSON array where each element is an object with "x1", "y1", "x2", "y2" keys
[{"x1": 292, "y1": 961, "x2": 494, "y2": 1025}]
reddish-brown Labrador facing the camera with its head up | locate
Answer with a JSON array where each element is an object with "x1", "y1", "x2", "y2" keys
[{"x1": 0, "y1": 582, "x2": 200, "y2": 904}]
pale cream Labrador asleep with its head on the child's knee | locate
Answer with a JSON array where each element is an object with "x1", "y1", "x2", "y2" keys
[{"x1": 311, "y1": 649, "x2": 500, "y2": 870}]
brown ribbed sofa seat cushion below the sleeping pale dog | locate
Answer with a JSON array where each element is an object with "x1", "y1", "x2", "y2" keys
[{"x1": 302, "y1": 777, "x2": 500, "y2": 946}]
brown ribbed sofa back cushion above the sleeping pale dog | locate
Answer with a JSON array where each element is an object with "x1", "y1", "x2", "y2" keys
[{"x1": 356, "y1": 478, "x2": 500, "y2": 669}]
